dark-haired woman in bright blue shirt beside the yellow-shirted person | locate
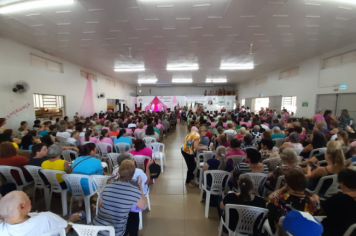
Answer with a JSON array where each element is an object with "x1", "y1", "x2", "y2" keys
[{"x1": 69, "y1": 143, "x2": 104, "y2": 196}]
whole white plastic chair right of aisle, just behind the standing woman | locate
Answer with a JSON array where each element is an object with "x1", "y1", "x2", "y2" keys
[{"x1": 200, "y1": 170, "x2": 231, "y2": 218}]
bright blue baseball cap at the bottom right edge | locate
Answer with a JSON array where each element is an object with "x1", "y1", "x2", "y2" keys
[{"x1": 282, "y1": 210, "x2": 323, "y2": 236}]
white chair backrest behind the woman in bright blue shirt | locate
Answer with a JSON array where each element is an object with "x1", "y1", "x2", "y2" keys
[{"x1": 62, "y1": 174, "x2": 94, "y2": 197}]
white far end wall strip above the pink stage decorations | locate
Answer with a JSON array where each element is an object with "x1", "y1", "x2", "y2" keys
[{"x1": 137, "y1": 85, "x2": 235, "y2": 96}]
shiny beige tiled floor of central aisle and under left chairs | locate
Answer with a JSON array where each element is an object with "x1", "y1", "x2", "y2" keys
[{"x1": 30, "y1": 125, "x2": 219, "y2": 236}]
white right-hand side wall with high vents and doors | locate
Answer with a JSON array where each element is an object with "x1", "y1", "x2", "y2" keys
[{"x1": 238, "y1": 44, "x2": 356, "y2": 117}]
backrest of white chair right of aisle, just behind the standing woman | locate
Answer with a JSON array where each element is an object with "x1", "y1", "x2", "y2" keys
[{"x1": 204, "y1": 170, "x2": 231, "y2": 192}]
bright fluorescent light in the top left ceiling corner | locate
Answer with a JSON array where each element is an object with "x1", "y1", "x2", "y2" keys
[{"x1": 0, "y1": 0, "x2": 74, "y2": 14}]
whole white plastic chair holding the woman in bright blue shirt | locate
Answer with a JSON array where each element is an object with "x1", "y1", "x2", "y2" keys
[{"x1": 62, "y1": 174, "x2": 96, "y2": 224}]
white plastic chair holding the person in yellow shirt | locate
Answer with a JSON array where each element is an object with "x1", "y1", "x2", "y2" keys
[{"x1": 40, "y1": 169, "x2": 68, "y2": 216}]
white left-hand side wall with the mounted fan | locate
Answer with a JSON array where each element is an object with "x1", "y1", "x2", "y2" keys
[{"x1": 0, "y1": 38, "x2": 133, "y2": 130}]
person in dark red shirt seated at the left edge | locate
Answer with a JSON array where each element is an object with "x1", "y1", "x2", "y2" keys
[{"x1": 0, "y1": 142, "x2": 33, "y2": 185}]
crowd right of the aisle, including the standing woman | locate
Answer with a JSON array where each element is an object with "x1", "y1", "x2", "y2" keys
[{"x1": 181, "y1": 107, "x2": 356, "y2": 236}]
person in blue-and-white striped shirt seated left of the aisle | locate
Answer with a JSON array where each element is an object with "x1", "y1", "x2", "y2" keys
[{"x1": 93, "y1": 160, "x2": 147, "y2": 236}]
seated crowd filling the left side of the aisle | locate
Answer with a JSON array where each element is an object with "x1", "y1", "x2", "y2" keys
[{"x1": 0, "y1": 112, "x2": 170, "y2": 236}]
